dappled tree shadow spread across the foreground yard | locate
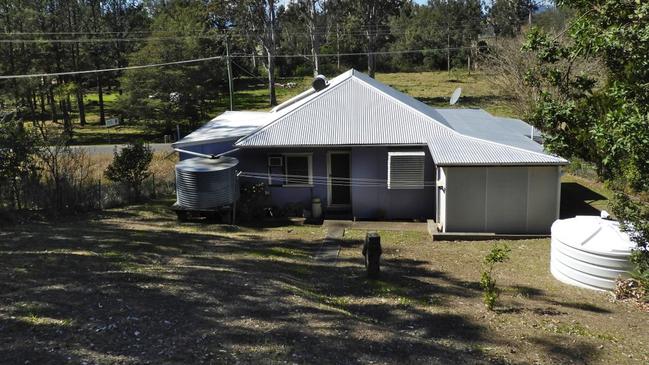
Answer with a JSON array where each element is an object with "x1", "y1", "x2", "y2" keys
[{"x1": 0, "y1": 203, "x2": 586, "y2": 364}]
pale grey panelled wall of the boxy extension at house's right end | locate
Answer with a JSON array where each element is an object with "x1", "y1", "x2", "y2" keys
[{"x1": 441, "y1": 166, "x2": 560, "y2": 233}]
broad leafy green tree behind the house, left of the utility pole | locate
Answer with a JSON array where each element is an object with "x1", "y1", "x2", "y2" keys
[{"x1": 118, "y1": 1, "x2": 227, "y2": 134}]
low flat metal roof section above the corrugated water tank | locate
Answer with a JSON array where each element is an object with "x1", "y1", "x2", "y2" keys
[{"x1": 171, "y1": 111, "x2": 271, "y2": 148}]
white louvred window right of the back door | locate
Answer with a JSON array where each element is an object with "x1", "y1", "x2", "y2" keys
[{"x1": 388, "y1": 151, "x2": 426, "y2": 189}]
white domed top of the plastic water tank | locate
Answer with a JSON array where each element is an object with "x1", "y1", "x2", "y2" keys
[{"x1": 552, "y1": 216, "x2": 636, "y2": 254}]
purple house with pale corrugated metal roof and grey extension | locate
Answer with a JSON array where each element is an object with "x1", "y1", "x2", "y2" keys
[{"x1": 174, "y1": 70, "x2": 567, "y2": 233}]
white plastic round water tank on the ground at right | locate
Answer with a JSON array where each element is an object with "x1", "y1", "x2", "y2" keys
[{"x1": 550, "y1": 216, "x2": 635, "y2": 290}]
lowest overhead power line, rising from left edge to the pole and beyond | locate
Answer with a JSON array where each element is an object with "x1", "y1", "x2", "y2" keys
[{"x1": 0, "y1": 47, "x2": 484, "y2": 80}]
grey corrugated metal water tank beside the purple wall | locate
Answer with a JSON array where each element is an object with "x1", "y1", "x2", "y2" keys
[{"x1": 176, "y1": 156, "x2": 239, "y2": 210}]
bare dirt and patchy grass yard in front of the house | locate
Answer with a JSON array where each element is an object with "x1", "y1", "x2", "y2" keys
[{"x1": 0, "y1": 201, "x2": 649, "y2": 364}]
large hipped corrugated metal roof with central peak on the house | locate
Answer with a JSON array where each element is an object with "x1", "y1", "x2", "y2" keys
[{"x1": 230, "y1": 70, "x2": 567, "y2": 165}]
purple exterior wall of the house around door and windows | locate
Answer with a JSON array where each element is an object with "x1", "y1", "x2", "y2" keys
[{"x1": 231, "y1": 147, "x2": 435, "y2": 219}]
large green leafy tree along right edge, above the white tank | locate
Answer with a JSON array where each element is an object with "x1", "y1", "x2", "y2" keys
[{"x1": 524, "y1": 0, "x2": 649, "y2": 287}]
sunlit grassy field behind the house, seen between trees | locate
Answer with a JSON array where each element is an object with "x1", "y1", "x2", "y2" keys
[{"x1": 40, "y1": 70, "x2": 516, "y2": 145}]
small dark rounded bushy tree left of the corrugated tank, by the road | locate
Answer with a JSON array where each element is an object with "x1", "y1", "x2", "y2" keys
[{"x1": 105, "y1": 142, "x2": 153, "y2": 199}]
